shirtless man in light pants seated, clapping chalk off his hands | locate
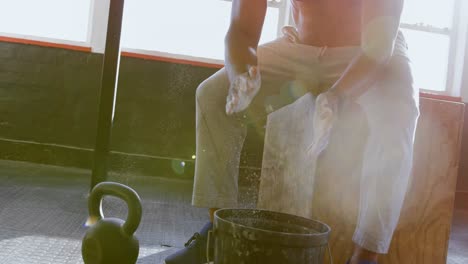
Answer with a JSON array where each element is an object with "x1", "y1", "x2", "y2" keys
[{"x1": 166, "y1": 0, "x2": 419, "y2": 264}]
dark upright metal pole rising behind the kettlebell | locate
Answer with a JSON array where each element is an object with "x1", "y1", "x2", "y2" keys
[{"x1": 91, "y1": 0, "x2": 124, "y2": 189}]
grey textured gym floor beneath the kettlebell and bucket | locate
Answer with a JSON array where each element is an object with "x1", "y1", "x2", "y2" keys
[{"x1": 0, "y1": 161, "x2": 468, "y2": 264}]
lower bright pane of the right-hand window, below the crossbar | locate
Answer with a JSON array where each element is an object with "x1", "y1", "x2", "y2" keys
[{"x1": 403, "y1": 29, "x2": 450, "y2": 91}]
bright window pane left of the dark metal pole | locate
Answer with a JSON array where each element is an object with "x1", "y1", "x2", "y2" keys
[{"x1": 0, "y1": 0, "x2": 91, "y2": 42}]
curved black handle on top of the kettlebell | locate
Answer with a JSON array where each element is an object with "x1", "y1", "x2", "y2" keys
[{"x1": 88, "y1": 182, "x2": 142, "y2": 236}]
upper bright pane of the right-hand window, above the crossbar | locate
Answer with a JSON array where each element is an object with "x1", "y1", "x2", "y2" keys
[{"x1": 401, "y1": 0, "x2": 454, "y2": 28}]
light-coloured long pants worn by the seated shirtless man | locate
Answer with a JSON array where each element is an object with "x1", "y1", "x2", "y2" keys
[{"x1": 192, "y1": 28, "x2": 419, "y2": 253}]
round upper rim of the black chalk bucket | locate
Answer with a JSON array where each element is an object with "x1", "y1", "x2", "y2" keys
[{"x1": 214, "y1": 208, "x2": 331, "y2": 245}]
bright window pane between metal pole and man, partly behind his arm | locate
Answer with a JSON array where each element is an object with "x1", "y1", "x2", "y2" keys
[{"x1": 122, "y1": 0, "x2": 279, "y2": 59}]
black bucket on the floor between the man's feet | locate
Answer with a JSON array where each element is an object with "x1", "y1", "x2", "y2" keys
[{"x1": 208, "y1": 209, "x2": 331, "y2": 264}]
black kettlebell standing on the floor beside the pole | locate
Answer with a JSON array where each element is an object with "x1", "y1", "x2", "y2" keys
[{"x1": 81, "y1": 182, "x2": 142, "y2": 264}]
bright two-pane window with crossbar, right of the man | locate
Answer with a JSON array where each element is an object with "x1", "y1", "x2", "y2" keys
[{"x1": 401, "y1": 0, "x2": 457, "y2": 92}]
